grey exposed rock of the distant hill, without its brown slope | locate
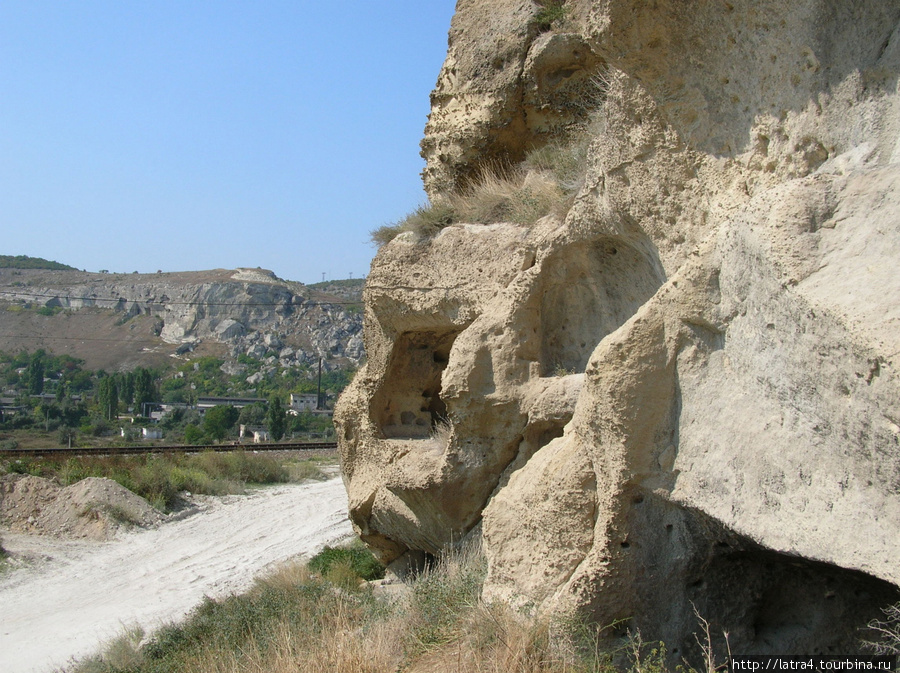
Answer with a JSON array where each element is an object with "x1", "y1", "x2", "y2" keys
[{"x1": 0, "y1": 268, "x2": 365, "y2": 367}]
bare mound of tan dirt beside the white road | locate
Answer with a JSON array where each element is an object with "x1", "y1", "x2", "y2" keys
[{"x1": 0, "y1": 475, "x2": 165, "y2": 540}]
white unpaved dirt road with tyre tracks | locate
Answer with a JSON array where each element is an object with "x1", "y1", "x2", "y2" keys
[{"x1": 0, "y1": 478, "x2": 351, "y2": 673}]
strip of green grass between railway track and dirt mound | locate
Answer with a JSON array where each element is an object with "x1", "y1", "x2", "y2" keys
[{"x1": 0, "y1": 451, "x2": 325, "y2": 511}]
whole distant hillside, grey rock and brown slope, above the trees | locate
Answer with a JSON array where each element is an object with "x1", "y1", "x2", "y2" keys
[{"x1": 0, "y1": 269, "x2": 364, "y2": 374}]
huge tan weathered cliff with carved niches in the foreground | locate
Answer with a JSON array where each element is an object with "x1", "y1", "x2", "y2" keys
[{"x1": 336, "y1": 0, "x2": 900, "y2": 661}]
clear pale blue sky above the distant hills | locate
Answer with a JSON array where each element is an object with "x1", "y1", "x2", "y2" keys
[{"x1": 0, "y1": 0, "x2": 455, "y2": 283}]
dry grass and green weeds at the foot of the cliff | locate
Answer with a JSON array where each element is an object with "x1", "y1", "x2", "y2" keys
[{"x1": 65, "y1": 542, "x2": 772, "y2": 673}]
